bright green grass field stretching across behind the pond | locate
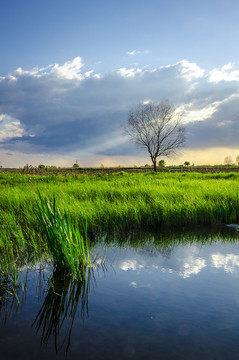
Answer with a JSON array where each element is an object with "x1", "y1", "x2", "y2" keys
[{"x1": 0, "y1": 172, "x2": 239, "y2": 239}]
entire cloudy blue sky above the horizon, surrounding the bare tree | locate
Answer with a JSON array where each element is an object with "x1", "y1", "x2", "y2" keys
[{"x1": 0, "y1": 0, "x2": 239, "y2": 167}]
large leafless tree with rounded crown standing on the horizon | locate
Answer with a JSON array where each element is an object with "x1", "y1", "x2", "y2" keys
[{"x1": 124, "y1": 101, "x2": 185, "y2": 171}]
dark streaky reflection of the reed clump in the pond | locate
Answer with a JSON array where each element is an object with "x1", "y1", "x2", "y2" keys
[{"x1": 32, "y1": 265, "x2": 101, "y2": 354}]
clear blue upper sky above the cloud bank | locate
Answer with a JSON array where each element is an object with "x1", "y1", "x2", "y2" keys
[{"x1": 0, "y1": 0, "x2": 239, "y2": 75}]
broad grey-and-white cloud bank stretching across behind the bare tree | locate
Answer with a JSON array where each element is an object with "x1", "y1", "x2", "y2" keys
[{"x1": 0, "y1": 57, "x2": 239, "y2": 166}]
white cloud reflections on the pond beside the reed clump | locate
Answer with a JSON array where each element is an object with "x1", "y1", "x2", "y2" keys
[{"x1": 109, "y1": 241, "x2": 239, "y2": 280}]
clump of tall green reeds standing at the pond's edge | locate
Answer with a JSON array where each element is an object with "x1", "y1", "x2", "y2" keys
[{"x1": 34, "y1": 195, "x2": 90, "y2": 280}]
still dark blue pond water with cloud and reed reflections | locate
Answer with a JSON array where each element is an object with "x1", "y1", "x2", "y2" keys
[{"x1": 0, "y1": 229, "x2": 239, "y2": 360}]
